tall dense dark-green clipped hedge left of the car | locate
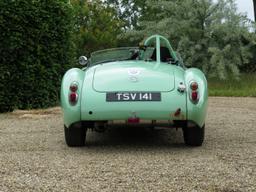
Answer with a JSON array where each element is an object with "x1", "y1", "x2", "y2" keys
[{"x1": 0, "y1": 0, "x2": 73, "y2": 112}]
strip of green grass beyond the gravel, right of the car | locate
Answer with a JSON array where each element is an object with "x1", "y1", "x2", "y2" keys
[{"x1": 208, "y1": 74, "x2": 256, "y2": 97}]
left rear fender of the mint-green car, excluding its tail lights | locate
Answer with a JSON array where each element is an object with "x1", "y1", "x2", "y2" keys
[{"x1": 60, "y1": 68, "x2": 85, "y2": 127}]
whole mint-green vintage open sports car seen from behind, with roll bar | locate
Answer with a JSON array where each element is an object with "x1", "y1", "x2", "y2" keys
[{"x1": 61, "y1": 35, "x2": 208, "y2": 146}]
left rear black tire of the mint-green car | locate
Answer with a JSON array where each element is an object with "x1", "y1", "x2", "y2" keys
[{"x1": 64, "y1": 124, "x2": 87, "y2": 147}]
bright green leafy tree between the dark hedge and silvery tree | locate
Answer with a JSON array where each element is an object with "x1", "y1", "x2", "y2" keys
[{"x1": 71, "y1": 0, "x2": 122, "y2": 56}]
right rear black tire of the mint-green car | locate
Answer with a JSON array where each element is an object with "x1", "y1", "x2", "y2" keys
[{"x1": 183, "y1": 125, "x2": 205, "y2": 146}]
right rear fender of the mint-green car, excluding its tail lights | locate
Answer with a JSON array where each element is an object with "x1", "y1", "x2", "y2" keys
[{"x1": 185, "y1": 68, "x2": 208, "y2": 127}]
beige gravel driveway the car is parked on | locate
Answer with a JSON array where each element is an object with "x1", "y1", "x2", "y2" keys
[{"x1": 0, "y1": 97, "x2": 256, "y2": 192}]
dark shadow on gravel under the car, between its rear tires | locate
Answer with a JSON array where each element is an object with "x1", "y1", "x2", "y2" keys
[{"x1": 86, "y1": 127, "x2": 186, "y2": 149}]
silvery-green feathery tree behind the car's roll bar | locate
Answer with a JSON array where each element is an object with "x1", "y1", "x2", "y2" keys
[{"x1": 122, "y1": 0, "x2": 256, "y2": 79}]
